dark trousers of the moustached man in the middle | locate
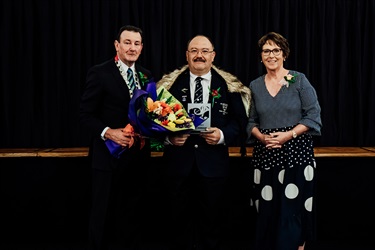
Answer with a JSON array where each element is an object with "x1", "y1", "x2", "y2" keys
[{"x1": 164, "y1": 165, "x2": 227, "y2": 250}]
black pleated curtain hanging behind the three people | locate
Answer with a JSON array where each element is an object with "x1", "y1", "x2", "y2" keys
[{"x1": 0, "y1": 0, "x2": 375, "y2": 147}]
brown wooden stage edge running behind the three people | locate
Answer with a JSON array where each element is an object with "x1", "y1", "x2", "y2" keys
[{"x1": 0, "y1": 147, "x2": 375, "y2": 158}]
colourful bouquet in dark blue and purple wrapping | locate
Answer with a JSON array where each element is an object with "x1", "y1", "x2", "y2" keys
[{"x1": 129, "y1": 82, "x2": 206, "y2": 141}]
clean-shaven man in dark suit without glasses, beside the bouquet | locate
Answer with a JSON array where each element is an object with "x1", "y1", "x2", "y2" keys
[{"x1": 80, "y1": 25, "x2": 152, "y2": 249}]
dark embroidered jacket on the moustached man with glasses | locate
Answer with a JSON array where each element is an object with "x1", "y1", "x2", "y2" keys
[{"x1": 163, "y1": 69, "x2": 247, "y2": 177}]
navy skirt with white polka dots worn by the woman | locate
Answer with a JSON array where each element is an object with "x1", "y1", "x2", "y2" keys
[{"x1": 252, "y1": 127, "x2": 316, "y2": 249}]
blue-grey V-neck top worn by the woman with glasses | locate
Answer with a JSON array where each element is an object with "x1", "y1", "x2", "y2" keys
[{"x1": 247, "y1": 70, "x2": 322, "y2": 141}]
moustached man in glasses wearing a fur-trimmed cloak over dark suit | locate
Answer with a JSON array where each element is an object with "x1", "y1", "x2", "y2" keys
[{"x1": 158, "y1": 35, "x2": 250, "y2": 250}]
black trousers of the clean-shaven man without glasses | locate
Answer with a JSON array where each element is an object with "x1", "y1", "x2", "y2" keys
[{"x1": 88, "y1": 168, "x2": 144, "y2": 250}]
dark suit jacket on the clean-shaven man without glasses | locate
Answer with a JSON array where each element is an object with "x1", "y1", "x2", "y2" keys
[{"x1": 80, "y1": 59, "x2": 152, "y2": 170}]
